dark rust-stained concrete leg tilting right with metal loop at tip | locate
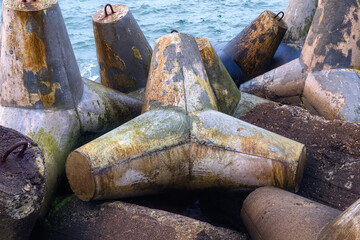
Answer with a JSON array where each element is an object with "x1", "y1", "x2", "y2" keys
[{"x1": 224, "y1": 11, "x2": 287, "y2": 83}]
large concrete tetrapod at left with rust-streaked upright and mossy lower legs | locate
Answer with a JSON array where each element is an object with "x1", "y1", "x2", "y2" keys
[{"x1": 0, "y1": 0, "x2": 141, "y2": 214}]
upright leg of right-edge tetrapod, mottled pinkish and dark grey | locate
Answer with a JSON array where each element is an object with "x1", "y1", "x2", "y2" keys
[{"x1": 300, "y1": 0, "x2": 360, "y2": 72}]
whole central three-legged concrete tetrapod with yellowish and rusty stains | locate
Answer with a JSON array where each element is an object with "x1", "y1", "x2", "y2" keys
[{"x1": 66, "y1": 33, "x2": 306, "y2": 201}]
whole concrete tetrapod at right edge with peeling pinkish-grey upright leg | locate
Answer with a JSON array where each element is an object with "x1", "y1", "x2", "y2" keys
[{"x1": 240, "y1": 0, "x2": 360, "y2": 122}]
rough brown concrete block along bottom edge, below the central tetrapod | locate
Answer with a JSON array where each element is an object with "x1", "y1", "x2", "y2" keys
[{"x1": 42, "y1": 196, "x2": 249, "y2": 240}]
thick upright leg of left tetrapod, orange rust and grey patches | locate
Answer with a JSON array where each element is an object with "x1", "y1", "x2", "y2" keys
[{"x1": 0, "y1": 0, "x2": 83, "y2": 109}]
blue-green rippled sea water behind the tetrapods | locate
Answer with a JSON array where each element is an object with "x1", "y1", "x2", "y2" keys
[{"x1": 0, "y1": 0, "x2": 288, "y2": 79}]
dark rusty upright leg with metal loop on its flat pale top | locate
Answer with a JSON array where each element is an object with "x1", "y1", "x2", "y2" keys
[{"x1": 92, "y1": 5, "x2": 152, "y2": 93}]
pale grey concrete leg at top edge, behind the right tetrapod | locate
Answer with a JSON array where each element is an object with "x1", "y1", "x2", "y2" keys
[{"x1": 283, "y1": 0, "x2": 318, "y2": 46}]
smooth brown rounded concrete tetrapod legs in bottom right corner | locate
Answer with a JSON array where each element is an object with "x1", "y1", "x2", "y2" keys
[{"x1": 241, "y1": 187, "x2": 360, "y2": 240}]
